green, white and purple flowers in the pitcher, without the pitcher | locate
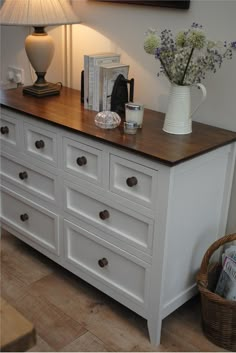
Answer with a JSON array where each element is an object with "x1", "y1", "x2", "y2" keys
[{"x1": 144, "y1": 22, "x2": 236, "y2": 86}]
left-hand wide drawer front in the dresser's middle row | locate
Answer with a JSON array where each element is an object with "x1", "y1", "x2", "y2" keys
[{"x1": 1, "y1": 155, "x2": 56, "y2": 202}]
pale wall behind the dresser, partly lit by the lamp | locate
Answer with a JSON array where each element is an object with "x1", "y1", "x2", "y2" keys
[{"x1": 1, "y1": 0, "x2": 236, "y2": 232}]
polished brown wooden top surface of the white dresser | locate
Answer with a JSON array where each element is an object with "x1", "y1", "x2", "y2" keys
[{"x1": 0, "y1": 87, "x2": 236, "y2": 166}]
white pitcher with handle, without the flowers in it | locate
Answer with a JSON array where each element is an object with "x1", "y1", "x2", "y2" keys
[{"x1": 163, "y1": 83, "x2": 207, "y2": 135}]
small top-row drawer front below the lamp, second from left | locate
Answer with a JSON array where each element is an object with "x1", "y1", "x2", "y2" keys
[{"x1": 24, "y1": 123, "x2": 57, "y2": 166}]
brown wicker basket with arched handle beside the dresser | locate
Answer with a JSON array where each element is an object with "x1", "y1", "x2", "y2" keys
[{"x1": 197, "y1": 233, "x2": 236, "y2": 351}]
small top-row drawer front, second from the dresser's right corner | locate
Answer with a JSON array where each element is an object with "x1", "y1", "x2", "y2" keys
[{"x1": 63, "y1": 138, "x2": 102, "y2": 185}]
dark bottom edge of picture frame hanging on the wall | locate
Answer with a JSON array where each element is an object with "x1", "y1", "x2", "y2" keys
[{"x1": 97, "y1": 0, "x2": 190, "y2": 10}]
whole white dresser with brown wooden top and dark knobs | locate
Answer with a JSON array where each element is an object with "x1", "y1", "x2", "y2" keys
[{"x1": 0, "y1": 88, "x2": 236, "y2": 344}]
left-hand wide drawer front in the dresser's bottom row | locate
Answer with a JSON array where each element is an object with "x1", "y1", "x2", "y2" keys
[{"x1": 1, "y1": 187, "x2": 59, "y2": 254}]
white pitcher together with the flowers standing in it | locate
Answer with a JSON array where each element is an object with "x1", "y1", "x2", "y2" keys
[{"x1": 144, "y1": 23, "x2": 236, "y2": 134}]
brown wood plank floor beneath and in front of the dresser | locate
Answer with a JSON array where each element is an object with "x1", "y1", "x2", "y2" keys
[{"x1": 1, "y1": 231, "x2": 223, "y2": 352}]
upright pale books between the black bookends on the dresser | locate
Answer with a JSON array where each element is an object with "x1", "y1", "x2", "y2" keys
[{"x1": 84, "y1": 53, "x2": 129, "y2": 111}]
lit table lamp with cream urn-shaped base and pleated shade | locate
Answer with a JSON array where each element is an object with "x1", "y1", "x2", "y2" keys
[{"x1": 0, "y1": 0, "x2": 80, "y2": 97}]
